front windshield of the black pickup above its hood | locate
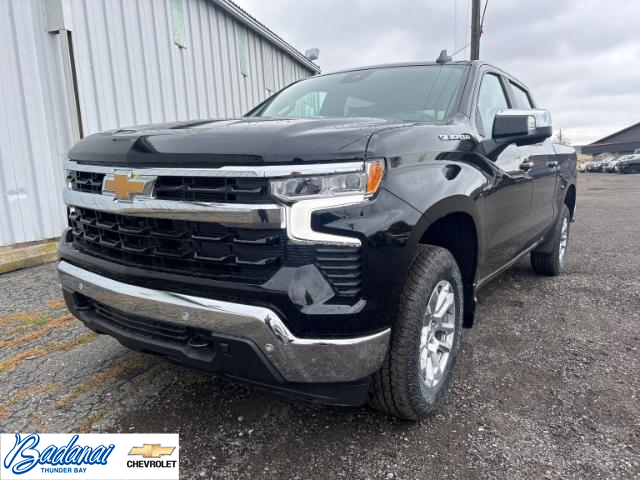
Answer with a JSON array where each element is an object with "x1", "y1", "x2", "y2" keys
[{"x1": 252, "y1": 65, "x2": 466, "y2": 121}]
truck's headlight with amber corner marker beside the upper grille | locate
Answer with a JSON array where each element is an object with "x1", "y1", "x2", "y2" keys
[{"x1": 271, "y1": 159, "x2": 384, "y2": 202}]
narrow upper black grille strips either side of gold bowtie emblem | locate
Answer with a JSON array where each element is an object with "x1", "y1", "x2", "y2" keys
[{"x1": 67, "y1": 171, "x2": 272, "y2": 204}]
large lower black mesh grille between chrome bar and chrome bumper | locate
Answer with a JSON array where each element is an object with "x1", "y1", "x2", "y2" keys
[{"x1": 69, "y1": 207, "x2": 286, "y2": 284}]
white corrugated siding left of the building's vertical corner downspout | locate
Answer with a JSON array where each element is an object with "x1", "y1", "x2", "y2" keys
[{"x1": 0, "y1": 0, "x2": 72, "y2": 245}]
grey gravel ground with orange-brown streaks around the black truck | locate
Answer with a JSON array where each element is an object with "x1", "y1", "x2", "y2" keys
[{"x1": 0, "y1": 174, "x2": 640, "y2": 479}]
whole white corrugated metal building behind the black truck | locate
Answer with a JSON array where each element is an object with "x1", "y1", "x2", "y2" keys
[{"x1": 0, "y1": 0, "x2": 319, "y2": 246}]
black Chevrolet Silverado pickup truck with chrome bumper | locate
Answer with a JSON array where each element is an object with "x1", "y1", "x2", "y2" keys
[{"x1": 59, "y1": 61, "x2": 576, "y2": 419}]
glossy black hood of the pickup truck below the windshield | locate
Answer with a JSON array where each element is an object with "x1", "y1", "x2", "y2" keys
[{"x1": 69, "y1": 118, "x2": 413, "y2": 167}]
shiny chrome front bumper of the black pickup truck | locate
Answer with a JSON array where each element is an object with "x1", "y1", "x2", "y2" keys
[{"x1": 58, "y1": 261, "x2": 390, "y2": 383}]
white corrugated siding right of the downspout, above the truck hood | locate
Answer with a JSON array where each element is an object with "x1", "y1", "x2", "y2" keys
[{"x1": 71, "y1": 0, "x2": 312, "y2": 134}]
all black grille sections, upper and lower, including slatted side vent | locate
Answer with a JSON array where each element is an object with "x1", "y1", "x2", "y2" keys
[{"x1": 68, "y1": 171, "x2": 362, "y2": 301}]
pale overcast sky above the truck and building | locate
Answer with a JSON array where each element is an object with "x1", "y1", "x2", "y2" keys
[{"x1": 235, "y1": 0, "x2": 640, "y2": 145}]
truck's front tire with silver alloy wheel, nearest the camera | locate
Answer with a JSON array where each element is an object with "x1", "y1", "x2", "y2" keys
[{"x1": 368, "y1": 245, "x2": 464, "y2": 420}]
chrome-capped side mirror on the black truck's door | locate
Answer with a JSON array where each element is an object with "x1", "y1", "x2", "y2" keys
[{"x1": 491, "y1": 109, "x2": 553, "y2": 146}]
